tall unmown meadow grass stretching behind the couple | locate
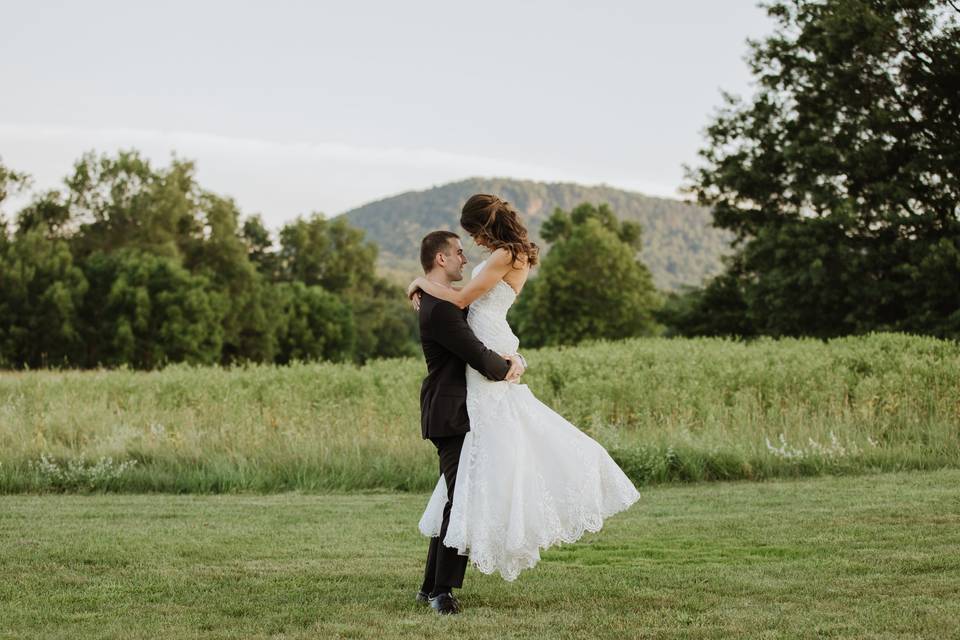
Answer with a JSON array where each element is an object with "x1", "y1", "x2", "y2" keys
[{"x1": 0, "y1": 334, "x2": 960, "y2": 493}]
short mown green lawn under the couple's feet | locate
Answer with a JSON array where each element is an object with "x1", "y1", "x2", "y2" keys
[{"x1": 0, "y1": 470, "x2": 960, "y2": 640}]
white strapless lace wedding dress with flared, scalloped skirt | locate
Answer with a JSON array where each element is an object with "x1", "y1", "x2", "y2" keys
[{"x1": 420, "y1": 263, "x2": 640, "y2": 581}]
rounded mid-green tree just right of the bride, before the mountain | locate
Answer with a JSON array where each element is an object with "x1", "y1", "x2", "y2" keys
[{"x1": 511, "y1": 204, "x2": 660, "y2": 346}]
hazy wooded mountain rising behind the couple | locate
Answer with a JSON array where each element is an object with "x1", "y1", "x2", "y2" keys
[{"x1": 343, "y1": 178, "x2": 732, "y2": 289}]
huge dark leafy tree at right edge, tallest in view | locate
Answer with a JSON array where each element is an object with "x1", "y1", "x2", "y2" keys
[{"x1": 688, "y1": 0, "x2": 960, "y2": 338}]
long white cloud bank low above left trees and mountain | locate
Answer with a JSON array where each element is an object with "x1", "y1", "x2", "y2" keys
[{"x1": 0, "y1": 123, "x2": 673, "y2": 226}]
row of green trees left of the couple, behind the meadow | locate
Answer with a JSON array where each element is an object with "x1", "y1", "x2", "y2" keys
[{"x1": 0, "y1": 151, "x2": 416, "y2": 369}]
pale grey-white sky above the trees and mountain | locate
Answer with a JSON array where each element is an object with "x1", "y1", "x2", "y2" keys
[{"x1": 0, "y1": 0, "x2": 772, "y2": 227}]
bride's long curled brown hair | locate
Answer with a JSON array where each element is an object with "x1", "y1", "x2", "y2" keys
[{"x1": 460, "y1": 193, "x2": 540, "y2": 267}]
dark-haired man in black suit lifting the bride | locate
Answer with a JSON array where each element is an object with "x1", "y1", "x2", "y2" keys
[{"x1": 414, "y1": 231, "x2": 524, "y2": 614}]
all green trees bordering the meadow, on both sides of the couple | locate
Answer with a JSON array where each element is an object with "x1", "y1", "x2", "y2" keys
[{"x1": 0, "y1": 0, "x2": 960, "y2": 368}]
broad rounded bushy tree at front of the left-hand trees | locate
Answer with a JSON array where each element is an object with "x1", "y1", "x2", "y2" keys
[{"x1": 83, "y1": 249, "x2": 223, "y2": 369}]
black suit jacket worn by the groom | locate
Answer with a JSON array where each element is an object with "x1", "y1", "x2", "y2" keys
[{"x1": 420, "y1": 293, "x2": 510, "y2": 439}]
